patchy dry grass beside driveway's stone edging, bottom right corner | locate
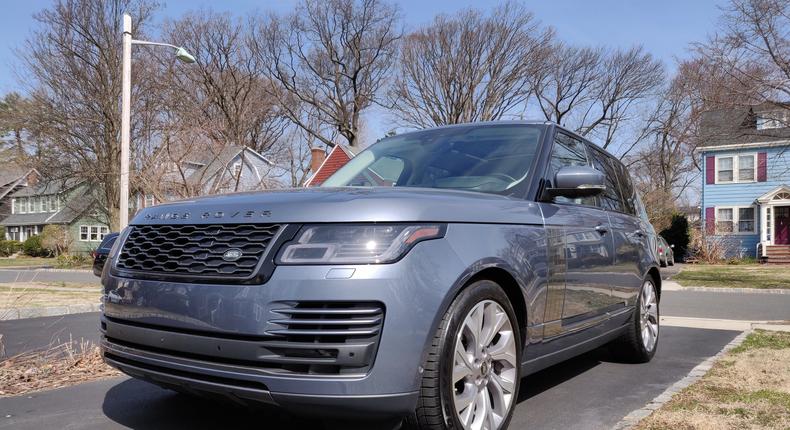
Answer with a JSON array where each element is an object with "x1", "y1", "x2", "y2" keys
[{"x1": 636, "y1": 330, "x2": 790, "y2": 430}]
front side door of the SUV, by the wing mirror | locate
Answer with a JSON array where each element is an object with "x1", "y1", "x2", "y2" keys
[{"x1": 541, "y1": 132, "x2": 614, "y2": 337}]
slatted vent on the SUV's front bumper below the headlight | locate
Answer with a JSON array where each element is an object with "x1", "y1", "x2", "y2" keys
[{"x1": 261, "y1": 302, "x2": 384, "y2": 374}]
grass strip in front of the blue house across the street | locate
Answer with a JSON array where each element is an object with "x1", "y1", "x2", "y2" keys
[{"x1": 672, "y1": 264, "x2": 790, "y2": 288}]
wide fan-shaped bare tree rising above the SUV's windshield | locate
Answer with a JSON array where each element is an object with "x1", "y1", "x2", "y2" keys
[{"x1": 390, "y1": 2, "x2": 552, "y2": 127}]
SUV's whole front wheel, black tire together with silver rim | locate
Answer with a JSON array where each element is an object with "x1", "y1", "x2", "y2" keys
[{"x1": 405, "y1": 280, "x2": 522, "y2": 430}]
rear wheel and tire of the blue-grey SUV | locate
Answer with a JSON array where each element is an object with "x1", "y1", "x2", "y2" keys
[{"x1": 611, "y1": 275, "x2": 661, "y2": 363}]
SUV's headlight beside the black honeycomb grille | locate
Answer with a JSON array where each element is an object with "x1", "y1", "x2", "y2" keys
[{"x1": 278, "y1": 224, "x2": 445, "y2": 264}]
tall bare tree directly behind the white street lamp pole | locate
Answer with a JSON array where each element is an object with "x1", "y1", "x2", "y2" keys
[{"x1": 18, "y1": 0, "x2": 162, "y2": 229}]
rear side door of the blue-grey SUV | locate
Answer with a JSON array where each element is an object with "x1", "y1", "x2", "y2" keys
[{"x1": 590, "y1": 148, "x2": 648, "y2": 308}]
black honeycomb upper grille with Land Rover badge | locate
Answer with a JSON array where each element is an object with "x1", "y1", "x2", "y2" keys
[{"x1": 116, "y1": 224, "x2": 280, "y2": 280}]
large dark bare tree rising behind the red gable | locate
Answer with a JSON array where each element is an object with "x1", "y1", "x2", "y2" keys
[{"x1": 249, "y1": 0, "x2": 402, "y2": 147}]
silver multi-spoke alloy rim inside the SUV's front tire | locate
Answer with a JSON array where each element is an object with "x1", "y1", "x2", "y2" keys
[{"x1": 451, "y1": 300, "x2": 518, "y2": 430}]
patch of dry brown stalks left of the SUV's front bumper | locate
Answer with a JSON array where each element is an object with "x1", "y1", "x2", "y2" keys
[{"x1": 0, "y1": 342, "x2": 121, "y2": 397}]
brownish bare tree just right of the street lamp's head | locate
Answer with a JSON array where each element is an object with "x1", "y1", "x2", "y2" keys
[{"x1": 156, "y1": 11, "x2": 286, "y2": 153}]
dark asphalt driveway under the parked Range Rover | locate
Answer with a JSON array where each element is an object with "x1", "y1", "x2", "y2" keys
[{"x1": 0, "y1": 327, "x2": 738, "y2": 430}]
